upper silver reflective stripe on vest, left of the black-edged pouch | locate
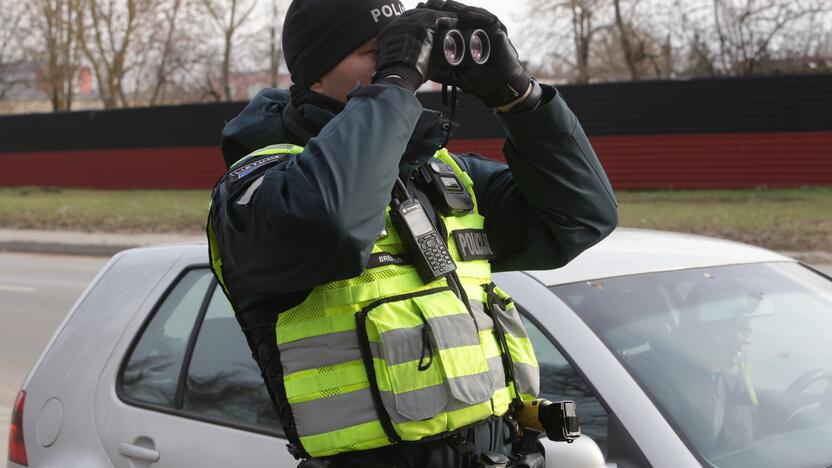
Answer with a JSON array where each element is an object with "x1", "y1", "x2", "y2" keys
[{"x1": 278, "y1": 331, "x2": 361, "y2": 374}]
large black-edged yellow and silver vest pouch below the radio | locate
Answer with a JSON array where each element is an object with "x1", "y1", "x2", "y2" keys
[{"x1": 356, "y1": 287, "x2": 496, "y2": 428}]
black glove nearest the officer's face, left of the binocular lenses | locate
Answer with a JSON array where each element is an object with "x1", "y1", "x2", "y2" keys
[{"x1": 373, "y1": 9, "x2": 456, "y2": 91}]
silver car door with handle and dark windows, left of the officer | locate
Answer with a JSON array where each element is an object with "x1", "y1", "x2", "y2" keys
[{"x1": 95, "y1": 267, "x2": 297, "y2": 468}]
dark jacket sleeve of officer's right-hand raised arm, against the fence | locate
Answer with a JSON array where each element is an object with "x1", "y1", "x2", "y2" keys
[{"x1": 459, "y1": 86, "x2": 618, "y2": 271}]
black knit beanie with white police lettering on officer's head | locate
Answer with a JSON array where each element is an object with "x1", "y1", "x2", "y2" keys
[{"x1": 283, "y1": 0, "x2": 404, "y2": 88}]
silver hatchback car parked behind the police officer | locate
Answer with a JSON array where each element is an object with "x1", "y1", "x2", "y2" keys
[{"x1": 9, "y1": 229, "x2": 832, "y2": 468}]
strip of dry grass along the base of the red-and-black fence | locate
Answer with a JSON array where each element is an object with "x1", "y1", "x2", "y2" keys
[{"x1": 0, "y1": 188, "x2": 832, "y2": 252}]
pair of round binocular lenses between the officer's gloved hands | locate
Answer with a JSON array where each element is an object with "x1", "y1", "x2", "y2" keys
[{"x1": 433, "y1": 29, "x2": 491, "y2": 67}]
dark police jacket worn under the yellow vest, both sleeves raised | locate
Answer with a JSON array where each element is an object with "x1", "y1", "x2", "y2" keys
[{"x1": 209, "y1": 85, "x2": 618, "y2": 444}]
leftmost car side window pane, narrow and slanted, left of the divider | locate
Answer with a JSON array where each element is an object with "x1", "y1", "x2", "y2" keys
[{"x1": 121, "y1": 269, "x2": 211, "y2": 407}]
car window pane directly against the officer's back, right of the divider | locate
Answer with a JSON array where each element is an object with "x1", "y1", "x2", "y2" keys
[{"x1": 183, "y1": 287, "x2": 282, "y2": 432}]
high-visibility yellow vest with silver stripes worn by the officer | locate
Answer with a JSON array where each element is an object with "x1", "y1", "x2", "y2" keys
[{"x1": 208, "y1": 145, "x2": 539, "y2": 457}]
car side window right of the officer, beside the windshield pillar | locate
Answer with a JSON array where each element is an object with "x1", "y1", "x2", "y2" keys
[{"x1": 523, "y1": 316, "x2": 608, "y2": 456}]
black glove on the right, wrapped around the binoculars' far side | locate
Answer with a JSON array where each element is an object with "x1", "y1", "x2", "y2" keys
[{"x1": 416, "y1": 0, "x2": 531, "y2": 107}]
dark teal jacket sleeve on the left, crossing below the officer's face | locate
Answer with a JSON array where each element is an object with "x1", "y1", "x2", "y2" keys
[{"x1": 210, "y1": 85, "x2": 422, "y2": 294}]
